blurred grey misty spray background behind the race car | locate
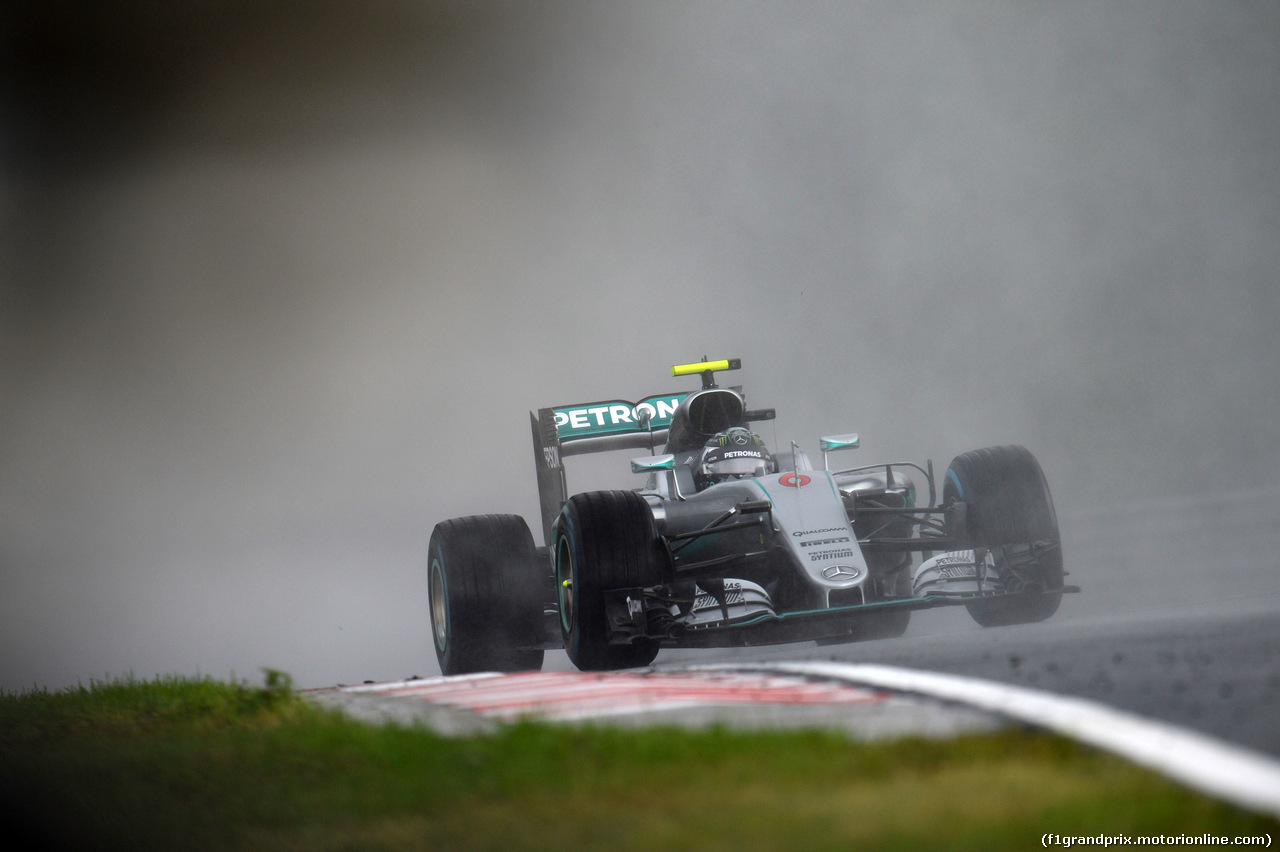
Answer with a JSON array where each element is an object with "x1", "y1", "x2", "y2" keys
[{"x1": 0, "y1": 0, "x2": 1280, "y2": 690}]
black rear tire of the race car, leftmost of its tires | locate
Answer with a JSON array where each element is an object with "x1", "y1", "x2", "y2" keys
[{"x1": 428, "y1": 514, "x2": 545, "y2": 674}]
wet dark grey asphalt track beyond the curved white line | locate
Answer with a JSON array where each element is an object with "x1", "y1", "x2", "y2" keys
[{"x1": 658, "y1": 600, "x2": 1280, "y2": 755}]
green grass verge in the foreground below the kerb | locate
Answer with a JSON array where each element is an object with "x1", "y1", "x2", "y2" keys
[{"x1": 0, "y1": 673, "x2": 1280, "y2": 852}]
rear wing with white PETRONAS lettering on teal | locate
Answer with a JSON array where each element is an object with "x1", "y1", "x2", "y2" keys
[{"x1": 529, "y1": 394, "x2": 689, "y2": 533}]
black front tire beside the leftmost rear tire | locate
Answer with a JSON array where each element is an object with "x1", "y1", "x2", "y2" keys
[{"x1": 552, "y1": 491, "x2": 666, "y2": 672}]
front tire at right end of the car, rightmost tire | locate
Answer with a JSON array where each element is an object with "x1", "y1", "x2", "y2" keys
[{"x1": 942, "y1": 446, "x2": 1062, "y2": 627}]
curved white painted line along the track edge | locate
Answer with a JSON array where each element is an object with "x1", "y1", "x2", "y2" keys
[{"x1": 689, "y1": 663, "x2": 1280, "y2": 816}]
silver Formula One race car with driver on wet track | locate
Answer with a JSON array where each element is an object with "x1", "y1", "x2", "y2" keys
[{"x1": 429, "y1": 358, "x2": 1079, "y2": 674}]
